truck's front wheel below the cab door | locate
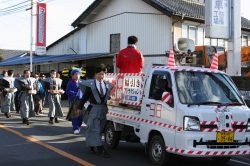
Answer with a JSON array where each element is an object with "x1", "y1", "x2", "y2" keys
[{"x1": 149, "y1": 135, "x2": 169, "y2": 166}]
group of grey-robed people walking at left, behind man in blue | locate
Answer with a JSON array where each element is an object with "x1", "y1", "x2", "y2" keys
[{"x1": 0, "y1": 70, "x2": 64, "y2": 125}]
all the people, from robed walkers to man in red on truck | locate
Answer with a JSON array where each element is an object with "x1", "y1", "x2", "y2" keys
[{"x1": 0, "y1": 36, "x2": 144, "y2": 158}]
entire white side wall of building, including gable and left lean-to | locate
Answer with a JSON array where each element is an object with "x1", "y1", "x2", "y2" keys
[{"x1": 47, "y1": 0, "x2": 172, "y2": 55}]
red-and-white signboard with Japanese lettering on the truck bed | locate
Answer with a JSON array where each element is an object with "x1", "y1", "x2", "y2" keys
[{"x1": 105, "y1": 73, "x2": 145, "y2": 106}]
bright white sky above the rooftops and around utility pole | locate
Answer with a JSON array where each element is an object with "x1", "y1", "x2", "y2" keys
[{"x1": 0, "y1": 0, "x2": 250, "y2": 51}]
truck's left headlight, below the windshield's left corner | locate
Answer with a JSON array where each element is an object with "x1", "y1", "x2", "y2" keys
[{"x1": 183, "y1": 116, "x2": 200, "y2": 131}]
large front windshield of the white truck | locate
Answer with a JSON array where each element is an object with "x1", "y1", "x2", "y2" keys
[{"x1": 175, "y1": 71, "x2": 245, "y2": 105}]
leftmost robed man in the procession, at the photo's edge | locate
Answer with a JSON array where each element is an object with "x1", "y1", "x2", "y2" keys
[{"x1": 1, "y1": 70, "x2": 17, "y2": 118}]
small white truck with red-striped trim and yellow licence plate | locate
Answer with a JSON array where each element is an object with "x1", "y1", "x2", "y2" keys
[{"x1": 104, "y1": 65, "x2": 250, "y2": 165}]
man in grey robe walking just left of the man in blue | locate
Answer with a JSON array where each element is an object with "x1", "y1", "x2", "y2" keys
[{"x1": 42, "y1": 70, "x2": 64, "y2": 124}]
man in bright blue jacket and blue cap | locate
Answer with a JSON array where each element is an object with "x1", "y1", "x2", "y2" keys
[{"x1": 66, "y1": 69, "x2": 85, "y2": 134}]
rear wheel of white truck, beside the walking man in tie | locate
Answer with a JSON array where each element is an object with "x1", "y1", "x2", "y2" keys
[{"x1": 104, "y1": 123, "x2": 121, "y2": 149}]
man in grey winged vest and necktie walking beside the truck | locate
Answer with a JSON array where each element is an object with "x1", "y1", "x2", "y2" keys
[{"x1": 77, "y1": 64, "x2": 113, "y2": 158}]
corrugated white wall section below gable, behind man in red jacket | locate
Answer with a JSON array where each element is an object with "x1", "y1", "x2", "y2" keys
[{"x1": 87, "y1": 13, "x2": 172, "y2": 55}]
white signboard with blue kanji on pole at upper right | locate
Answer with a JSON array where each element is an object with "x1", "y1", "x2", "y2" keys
[{"x1": 205, "y1": 0, "x2": 231, "y2": 39}]
